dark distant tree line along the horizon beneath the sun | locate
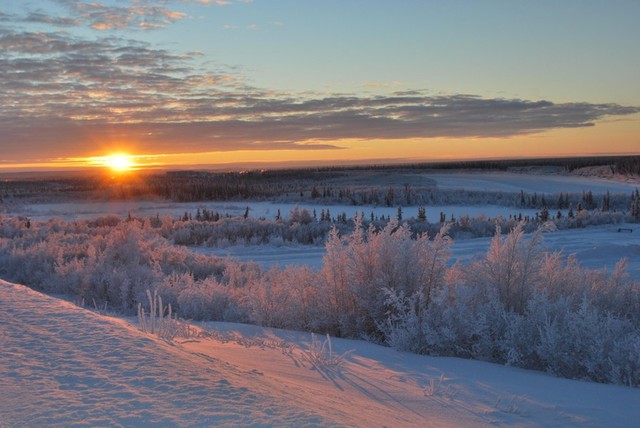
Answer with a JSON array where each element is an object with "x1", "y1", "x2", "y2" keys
[{"x1": 0, "y1": 156, "x2": 640, "y2": 206}]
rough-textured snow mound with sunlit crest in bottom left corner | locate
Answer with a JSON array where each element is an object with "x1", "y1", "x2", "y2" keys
[{"x1": 0, "y1": 282, "x2": 335, "y2": 427}]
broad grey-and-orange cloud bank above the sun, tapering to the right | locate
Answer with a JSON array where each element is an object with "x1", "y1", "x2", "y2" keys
[{"x1": 0, "y1": 24, "x2": 640, "y2": 161}]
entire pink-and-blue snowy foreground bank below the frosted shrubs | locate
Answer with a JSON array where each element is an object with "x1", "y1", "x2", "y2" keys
[{"x1": 0, "y1": 281, "x2": 640, "y2": 427}]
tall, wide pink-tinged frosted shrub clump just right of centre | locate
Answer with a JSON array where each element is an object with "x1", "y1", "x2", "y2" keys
[{"x1": 322, "y1": 217, "x2": 451, "y2": 337}]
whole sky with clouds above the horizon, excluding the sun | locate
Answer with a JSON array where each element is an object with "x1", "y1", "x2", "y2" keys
[{"x1": 0, "y1": 0, "x2": 640, "y2": 171}]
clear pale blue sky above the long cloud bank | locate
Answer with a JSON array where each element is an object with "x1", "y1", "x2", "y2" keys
[{"x1": 147, "y1": 0, "x2": 640, "y2": 104}]
